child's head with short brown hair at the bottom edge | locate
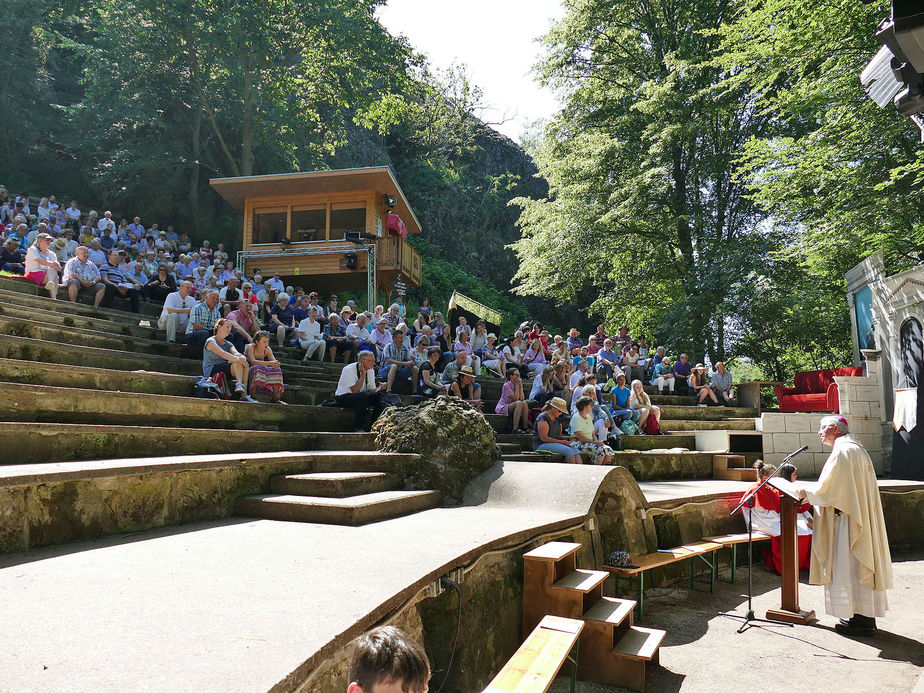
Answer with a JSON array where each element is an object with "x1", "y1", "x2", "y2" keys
[{"x1": 347, "y1": 626, "x2": 430, "y2": 693}]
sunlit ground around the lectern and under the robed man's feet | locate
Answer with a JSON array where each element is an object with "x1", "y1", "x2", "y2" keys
[{"x1": 551, "y1": 551, "x2": 924, "y2": 693}]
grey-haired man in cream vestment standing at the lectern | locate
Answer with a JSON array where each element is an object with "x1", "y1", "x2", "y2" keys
[{"x1": 799, "y1": 416, "x2": 892, "y2": 635}]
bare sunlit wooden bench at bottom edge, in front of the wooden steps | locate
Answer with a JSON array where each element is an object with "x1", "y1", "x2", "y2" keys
[{"x1": 484, "y1": 616, "x2": 584, "y2": 693}]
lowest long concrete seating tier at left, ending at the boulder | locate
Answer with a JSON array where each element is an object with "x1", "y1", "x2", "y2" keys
[{"x1": 0, "y1": 422, "x2": 382, "y2": 464}]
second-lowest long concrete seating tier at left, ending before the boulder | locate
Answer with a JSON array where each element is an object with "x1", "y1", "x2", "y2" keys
[{"x1": 0, "y1": 383, "x2": 353, "y2": 431}]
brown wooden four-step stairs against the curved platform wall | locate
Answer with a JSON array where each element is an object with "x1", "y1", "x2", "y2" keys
[{"x1": 523, "y1": 541, "x2": 665, "y2": 691}]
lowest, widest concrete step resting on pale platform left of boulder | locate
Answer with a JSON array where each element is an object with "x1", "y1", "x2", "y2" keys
[{"x1": 236, "y1": 491, "x2": 440, "y2": 525}]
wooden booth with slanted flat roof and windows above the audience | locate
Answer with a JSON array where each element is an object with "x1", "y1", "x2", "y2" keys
[{"x1": 209, "y1": 166, "x2": 422, "y2": 310}]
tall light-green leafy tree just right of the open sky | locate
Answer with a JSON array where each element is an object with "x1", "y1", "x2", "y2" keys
[{"x1": 514, "y1": 0, "x2": 769, "y2": 359}]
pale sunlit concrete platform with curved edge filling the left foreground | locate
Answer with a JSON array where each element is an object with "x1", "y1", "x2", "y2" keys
[{"x1": 0, "y1": 462, "x2": 613, "y2": 693}]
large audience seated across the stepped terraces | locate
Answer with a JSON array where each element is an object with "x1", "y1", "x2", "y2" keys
[{"x1": 0, "y1": 186, "x2": 733, "y2": 430}]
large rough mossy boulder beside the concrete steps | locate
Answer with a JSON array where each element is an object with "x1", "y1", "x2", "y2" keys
[{"x1": 372, "y1": 397, "x2": 501, "y2": 505}]
